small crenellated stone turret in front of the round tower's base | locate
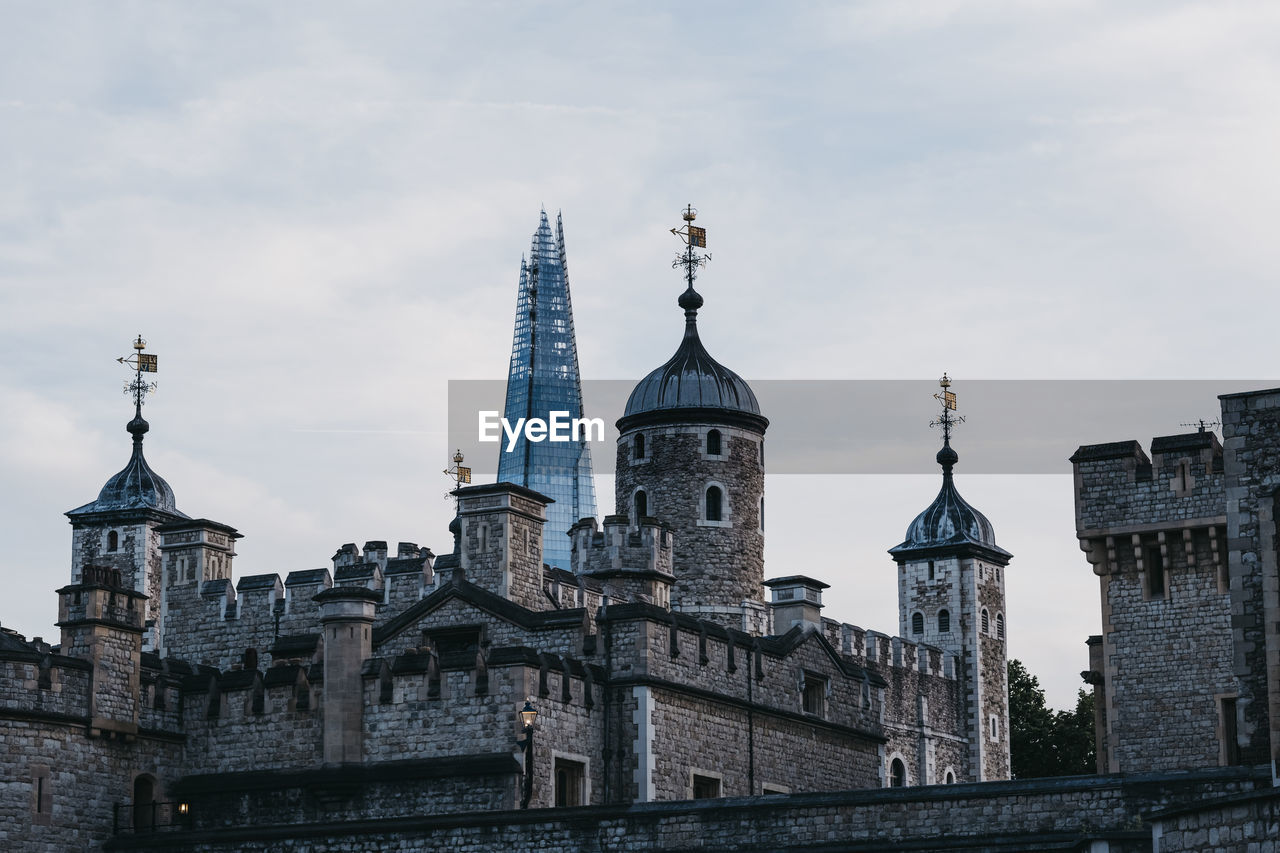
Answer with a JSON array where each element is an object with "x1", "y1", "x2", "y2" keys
[{"x1": 570, "y1": 515, "x2": 676, "y2": 607}]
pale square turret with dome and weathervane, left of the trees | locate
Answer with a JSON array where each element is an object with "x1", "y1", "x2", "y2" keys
[{"x1": 890, "y1": 375, "x2": 1012, "y2": 781}]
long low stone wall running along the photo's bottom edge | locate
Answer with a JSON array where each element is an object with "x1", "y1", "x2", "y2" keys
[{"x1": 108, "y1": 770, "x2": 1266, "y2": 853}]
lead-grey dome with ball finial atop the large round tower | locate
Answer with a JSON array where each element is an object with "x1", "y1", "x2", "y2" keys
[{"x1": 618, "y1": 286, "x2": 769, "y2": 432}]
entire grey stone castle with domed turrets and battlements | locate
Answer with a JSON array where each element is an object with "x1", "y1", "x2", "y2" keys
[{"x1": 0, "y1": 222, "x2": 1280, "y2": 852}]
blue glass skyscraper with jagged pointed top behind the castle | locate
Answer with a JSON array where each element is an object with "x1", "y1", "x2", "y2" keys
[{"x1": 498, "y1": 210, "x2": 595, "y2": 569}]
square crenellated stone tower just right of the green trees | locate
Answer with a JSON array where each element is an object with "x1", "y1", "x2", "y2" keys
[{"x1": 1071, "y1": 433, "x2": 1239, "y2": 772}]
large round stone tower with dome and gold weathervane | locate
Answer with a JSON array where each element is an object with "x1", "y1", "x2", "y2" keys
[{"x1": 614, "y1": 207, "x2": 769, "y2": 633}]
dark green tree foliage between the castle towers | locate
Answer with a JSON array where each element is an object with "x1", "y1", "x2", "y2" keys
[{"x1": 1009, "y1": 660, "x2": 1094, "y2": 779}]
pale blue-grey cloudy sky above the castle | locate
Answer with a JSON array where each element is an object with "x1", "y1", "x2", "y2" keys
[{"x1": 0, "y1": 0, "x2": 1280, "y2": 707}]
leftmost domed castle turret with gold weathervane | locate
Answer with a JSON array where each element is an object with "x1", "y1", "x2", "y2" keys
[{"x1": 67, "y1": 336, "x2": 187, "y2": 651}]
